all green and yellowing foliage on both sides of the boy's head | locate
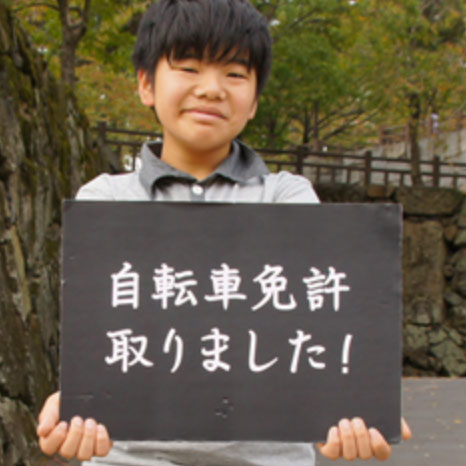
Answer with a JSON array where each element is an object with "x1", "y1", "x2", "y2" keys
[{"x1": 11, "y1": 0, "x2": 466, "y2": 148}]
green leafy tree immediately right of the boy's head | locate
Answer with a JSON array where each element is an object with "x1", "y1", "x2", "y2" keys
[{"x1": 247, "y1": 0, "x2": 392, "y2": 149}]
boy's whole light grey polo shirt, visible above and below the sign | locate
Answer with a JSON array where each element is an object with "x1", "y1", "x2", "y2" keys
[{"x1": 76, "y1": 141, "x2": 319, "y2": 466}]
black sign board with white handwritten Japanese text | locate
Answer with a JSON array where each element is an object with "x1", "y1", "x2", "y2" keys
[{"x1": 60, "y1": 201, "x2": 401, "y2": 442}]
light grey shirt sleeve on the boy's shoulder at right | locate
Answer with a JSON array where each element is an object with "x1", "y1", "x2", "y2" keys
[{"x1": 273, "y1": 172, "x2": 320, "y2": 204}]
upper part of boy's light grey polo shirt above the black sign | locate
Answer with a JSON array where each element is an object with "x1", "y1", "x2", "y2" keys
[{"x1": 77, "y1": 141, "x2": 319, "y2": 203}]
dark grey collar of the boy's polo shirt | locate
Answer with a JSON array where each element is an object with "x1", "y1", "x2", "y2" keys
[{"x1": 139, "y1": 140, "x2": 269, "y2": 193}]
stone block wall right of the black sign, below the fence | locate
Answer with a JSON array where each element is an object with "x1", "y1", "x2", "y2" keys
[{"x1": 316, "y1": 185, "x2": 466, "y2": 376}]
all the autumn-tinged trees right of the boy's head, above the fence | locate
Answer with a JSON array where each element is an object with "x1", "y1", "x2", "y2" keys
[{"x1": 247, "y1": 0, "x2": 466, "y2": 162}]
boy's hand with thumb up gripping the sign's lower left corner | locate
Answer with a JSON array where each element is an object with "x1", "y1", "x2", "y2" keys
[{"x1": 37, "y1": 392, "x2": 112, "y2": 461}]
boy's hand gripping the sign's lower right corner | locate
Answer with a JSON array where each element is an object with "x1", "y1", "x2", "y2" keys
[{"x1": 318, "y1": 418, "x2": 411, "y2": 461}]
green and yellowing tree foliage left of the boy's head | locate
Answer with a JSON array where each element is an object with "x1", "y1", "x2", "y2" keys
[{"x1": 14, "y1": 0, "x2": 156, "y2": 130}]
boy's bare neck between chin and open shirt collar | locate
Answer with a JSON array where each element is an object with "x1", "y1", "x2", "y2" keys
[{"x1": 160, "y1": 140, "x2": 231, "y2": 181}]
